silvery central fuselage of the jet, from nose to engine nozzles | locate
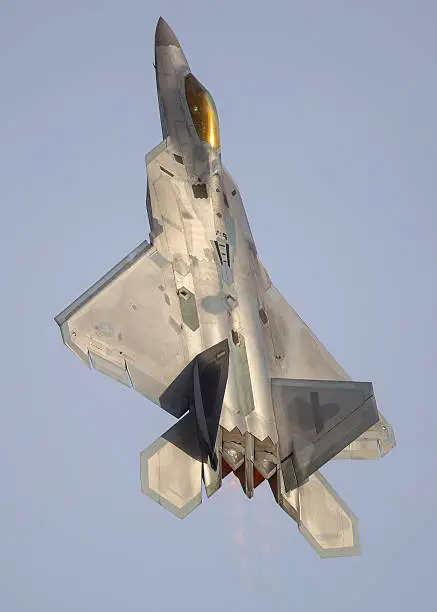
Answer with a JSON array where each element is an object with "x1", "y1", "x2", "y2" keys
[{"x1": 152, "y1": 22, "x2": 277, "y2": 450}]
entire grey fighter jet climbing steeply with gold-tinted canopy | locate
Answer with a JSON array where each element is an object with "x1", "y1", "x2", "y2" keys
[{"x1": 56, "y1": 18, "x2": 395, "y2": 557}]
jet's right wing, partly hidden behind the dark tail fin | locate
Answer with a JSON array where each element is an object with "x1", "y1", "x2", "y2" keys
[{"x1": 264, "y1": 280, "x2": 395, "y2": 459}]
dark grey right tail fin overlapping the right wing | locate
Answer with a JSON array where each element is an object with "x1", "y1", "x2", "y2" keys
[{"x1": 272, "y1": 378, "x2": 379, "y2": 491}]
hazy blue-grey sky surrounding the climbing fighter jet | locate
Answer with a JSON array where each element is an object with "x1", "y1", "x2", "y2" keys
[{"x1": 0, "y1": 0, "x2": 437, "y2": 612}]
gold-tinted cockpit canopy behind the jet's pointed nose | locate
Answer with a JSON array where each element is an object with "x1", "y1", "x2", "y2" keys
[{"x1": 185, "y1": 73, "x2": 220, "y2": 149}]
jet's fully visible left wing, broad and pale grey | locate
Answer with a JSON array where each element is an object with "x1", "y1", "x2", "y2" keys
[{"x1": 55, "y1": 242, "x2": 189, "y2": 405}]
